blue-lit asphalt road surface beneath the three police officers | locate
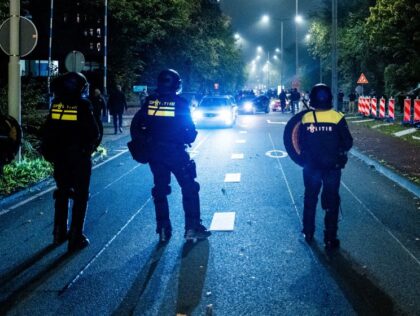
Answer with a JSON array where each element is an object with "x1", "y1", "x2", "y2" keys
[{"x1": 0, "y1": 113, "x2": 420, "y2": 316}]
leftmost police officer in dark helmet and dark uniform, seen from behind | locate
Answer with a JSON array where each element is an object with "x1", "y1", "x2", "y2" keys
[{"x1": 41, "y1": 72, "x2": 100, "y2": 251}]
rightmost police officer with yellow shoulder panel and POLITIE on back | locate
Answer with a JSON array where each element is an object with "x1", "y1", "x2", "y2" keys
[{"x1": 299, "y1": 84, "x2": 353, "y2": 250}]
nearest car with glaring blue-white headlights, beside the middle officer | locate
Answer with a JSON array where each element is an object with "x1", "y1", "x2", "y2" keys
[{"x1": 192, "y1": 95, "x2": 238, "y2": 127}]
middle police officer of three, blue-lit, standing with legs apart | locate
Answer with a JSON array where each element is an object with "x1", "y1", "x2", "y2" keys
[{"x1": 130, "y1": 69, "x2": 211, "y2": 243}]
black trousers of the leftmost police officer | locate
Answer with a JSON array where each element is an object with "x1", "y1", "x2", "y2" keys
[{"x1": 53, "y1": 156, "x2": 92, "y2": 236}]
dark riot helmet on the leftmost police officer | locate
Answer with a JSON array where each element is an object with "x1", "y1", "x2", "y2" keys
[{"x1": 51, "y1": 72, "x2": 89, "y2": 98}]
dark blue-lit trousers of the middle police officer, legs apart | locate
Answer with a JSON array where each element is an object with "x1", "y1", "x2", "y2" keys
[{"x1": 149, "y1": 147, "x2": 200, "y2": 232}]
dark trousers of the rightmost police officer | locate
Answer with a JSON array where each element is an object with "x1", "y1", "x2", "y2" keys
[{"x1": 303, "y1": 167, "x2": 341, "y2": 239}]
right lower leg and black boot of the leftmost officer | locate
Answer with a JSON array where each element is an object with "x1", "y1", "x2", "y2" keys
[{"x1": 68, "y1": 200, "x2": 89, "y2": 252}]
